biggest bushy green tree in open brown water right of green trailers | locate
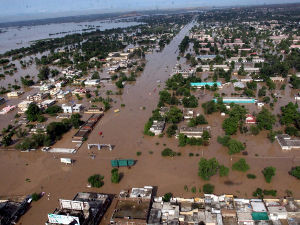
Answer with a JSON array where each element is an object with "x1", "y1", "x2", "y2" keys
[{"x1": 198, "y1": 158, "x2": 219, "y2": 180}]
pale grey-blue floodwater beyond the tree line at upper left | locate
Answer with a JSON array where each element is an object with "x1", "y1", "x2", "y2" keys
[{"x1": 0, "y1": 21, "x2": 140, "y2": 54}]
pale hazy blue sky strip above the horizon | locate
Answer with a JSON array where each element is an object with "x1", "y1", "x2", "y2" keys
[{"x1": 0, "y1": 0, "x2": 300, "y2": 20}]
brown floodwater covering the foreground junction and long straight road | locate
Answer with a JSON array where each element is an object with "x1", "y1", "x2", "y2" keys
[{"x1": 0, "y1": 20, "x2": 300, "y2": 225}]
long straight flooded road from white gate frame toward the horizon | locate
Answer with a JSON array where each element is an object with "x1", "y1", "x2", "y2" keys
[{"x1": 89, "y1": 21, "x2": 196, "y2": 151}]
